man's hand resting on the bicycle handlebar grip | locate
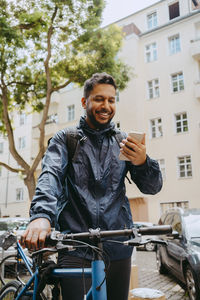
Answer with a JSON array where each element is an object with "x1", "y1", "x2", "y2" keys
[{"x1": 21, "y1": 218, "x2": 51, "y2": 251}]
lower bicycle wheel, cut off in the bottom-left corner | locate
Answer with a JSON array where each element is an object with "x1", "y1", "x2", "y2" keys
[{"x1": 0, "y1": 280, "x2": 21, "y2": 300}]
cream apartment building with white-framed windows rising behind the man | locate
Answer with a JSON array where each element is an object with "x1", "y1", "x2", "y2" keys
[{"x1": 0, "y1": 0, "x2": 200, "y2": 222}]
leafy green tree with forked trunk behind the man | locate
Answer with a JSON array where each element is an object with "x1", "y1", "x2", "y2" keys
[{"x1": 0, "y1": 0, "x2": 130, "y2": 199}]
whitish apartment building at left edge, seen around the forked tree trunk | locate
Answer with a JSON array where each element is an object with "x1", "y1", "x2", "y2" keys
[{"x1": 0, "y1": 110, "x2": 32, "y2": 217}]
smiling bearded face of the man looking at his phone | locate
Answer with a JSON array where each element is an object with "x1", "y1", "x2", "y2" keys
[{"x1": 81, "y1": 84, "x2": 116, "y2": 129}]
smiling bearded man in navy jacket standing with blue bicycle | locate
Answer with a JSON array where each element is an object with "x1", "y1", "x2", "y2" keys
[{"x1": 23, "y1": 73, "x2": 162, "y2": 300}]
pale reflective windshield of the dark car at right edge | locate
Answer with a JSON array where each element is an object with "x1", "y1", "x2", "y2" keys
[{"x1": 184, "y1": 215, "x2": 200, "y2": 239}]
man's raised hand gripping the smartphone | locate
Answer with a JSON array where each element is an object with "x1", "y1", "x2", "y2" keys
[{"x1": 120, "y1": 135, "x2": 146, "y2": 166}]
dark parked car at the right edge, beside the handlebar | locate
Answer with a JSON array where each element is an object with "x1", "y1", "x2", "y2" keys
[{"x1": 156, "y1": 208, "x2": 200, "y2": 300}]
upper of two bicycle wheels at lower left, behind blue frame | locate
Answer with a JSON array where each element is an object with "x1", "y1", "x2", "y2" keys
[{"x1": 0, "y1": 254, "x2": 31, "y2": 285}]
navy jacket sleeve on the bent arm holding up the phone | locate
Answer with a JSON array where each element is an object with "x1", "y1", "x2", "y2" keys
[{"x1": 127, "y1": 155, "x2": 163, "y2": 195}]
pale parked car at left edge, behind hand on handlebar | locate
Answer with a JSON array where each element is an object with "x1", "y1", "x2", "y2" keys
[{"x1": 0, "y1": 217, "x2": 29, "y2": 261}]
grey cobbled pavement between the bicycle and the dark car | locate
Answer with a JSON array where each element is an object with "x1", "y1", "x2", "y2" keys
[{"x1": 135, "y1": 251, "x2": 189, "y2": 300}]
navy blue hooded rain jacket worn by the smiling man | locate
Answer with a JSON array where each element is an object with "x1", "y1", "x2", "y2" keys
[{"x1": 30, "y1": 117, "x2": 162, "y2": 260}]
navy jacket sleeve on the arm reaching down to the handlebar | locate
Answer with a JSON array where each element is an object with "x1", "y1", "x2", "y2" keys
[{"x1": 30, "y1": 130, "x2": 68, "y2": 225}]
